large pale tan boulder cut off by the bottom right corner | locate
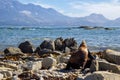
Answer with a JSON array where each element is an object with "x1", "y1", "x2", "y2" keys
[{"x1": 84, "y1": 71, "x2": 120, "y2": 80}]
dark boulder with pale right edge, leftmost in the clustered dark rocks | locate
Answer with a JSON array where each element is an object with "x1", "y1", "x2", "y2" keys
[{"x1": 40, "y1": 40, "x2": 55, "y2": 51}]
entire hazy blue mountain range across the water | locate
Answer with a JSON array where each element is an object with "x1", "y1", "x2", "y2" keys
[{"x1": 0, "y1": 0, "x2": 120, "y2": 26}]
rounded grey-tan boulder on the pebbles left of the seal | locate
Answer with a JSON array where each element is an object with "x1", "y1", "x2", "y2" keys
[{"x1": 42, "y1": 57, "x2": 57, "y2": 69}]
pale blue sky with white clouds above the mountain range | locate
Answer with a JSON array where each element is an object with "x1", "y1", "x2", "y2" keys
[{"x1": 18, "y1": 0, "x2": 120, "y2": 20}]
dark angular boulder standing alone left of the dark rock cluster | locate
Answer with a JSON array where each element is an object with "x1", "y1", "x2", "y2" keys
[{"x1": 18, "y1": 41, "x2": 33, "y2": 53}]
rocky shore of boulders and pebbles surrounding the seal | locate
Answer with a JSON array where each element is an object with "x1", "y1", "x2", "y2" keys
[{"x1": 0, "y1": 37, "x2": 120, "y2": 80}]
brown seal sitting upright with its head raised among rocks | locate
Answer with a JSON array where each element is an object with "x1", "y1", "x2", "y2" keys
[{"x1": 66, "y1": 41, "x2": 94, "y2": 70}]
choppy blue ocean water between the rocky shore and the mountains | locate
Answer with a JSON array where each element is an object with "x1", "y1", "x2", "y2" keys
[{"x1": 0, "y1": 26, "x2": 120, "y2": 51}]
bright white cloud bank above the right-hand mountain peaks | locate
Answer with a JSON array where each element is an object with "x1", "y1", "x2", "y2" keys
[{"x1": 68, "y1": 0, "x2": 120, "y2": 19}]
